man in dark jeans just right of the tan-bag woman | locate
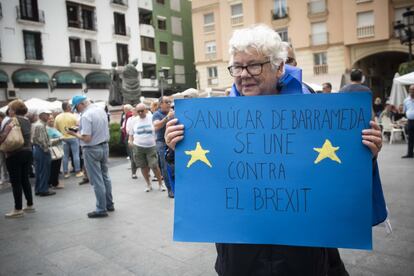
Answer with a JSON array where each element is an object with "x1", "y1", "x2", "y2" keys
[{"x1": 32, "y1": 109, "x2": 60, "y2": 196}]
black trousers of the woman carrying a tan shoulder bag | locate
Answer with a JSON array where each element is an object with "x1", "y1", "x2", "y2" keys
[{"x1": 6, "y1": 150, "x2": 33, "y2": 210}]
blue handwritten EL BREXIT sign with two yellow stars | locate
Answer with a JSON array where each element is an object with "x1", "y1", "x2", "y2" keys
[{"x1": 174, "y1": 93, "x2": 372, "y2": 249}]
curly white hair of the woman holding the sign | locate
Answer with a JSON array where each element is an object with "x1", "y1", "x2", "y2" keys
[{"x1": 229, "y1": 24, "x2": 287, "y2": 69}]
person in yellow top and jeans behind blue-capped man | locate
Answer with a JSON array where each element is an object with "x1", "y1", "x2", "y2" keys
[{"x1": 55, "y1": 102, "x2": 83, "y2": 178}]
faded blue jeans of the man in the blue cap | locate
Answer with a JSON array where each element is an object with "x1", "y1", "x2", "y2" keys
[{"x1": 82, "y1": 143, "x2": 114, "y2": 213}]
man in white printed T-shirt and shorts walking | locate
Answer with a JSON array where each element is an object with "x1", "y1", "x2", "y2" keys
[{"x1": 128, "y1": 103, "x2": 166, "y2": 192}]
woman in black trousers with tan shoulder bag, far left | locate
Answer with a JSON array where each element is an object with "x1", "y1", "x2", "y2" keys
[{"x1": 0, "y1": 100, "x2": 35, "y2": 218}]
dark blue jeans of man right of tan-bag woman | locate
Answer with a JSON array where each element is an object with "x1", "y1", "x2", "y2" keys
[{"x1": 33, "y1": 145, "x2": 52, "y2": 193}]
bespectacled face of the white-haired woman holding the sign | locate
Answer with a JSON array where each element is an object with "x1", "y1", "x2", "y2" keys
[{"x1": 231, "y1": 51, "x2": 283, "y2": 96}]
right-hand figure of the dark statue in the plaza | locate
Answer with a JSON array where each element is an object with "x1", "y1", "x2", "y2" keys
[{"x1": 121, "y1": 59, "x2": 141, "y2": 106}]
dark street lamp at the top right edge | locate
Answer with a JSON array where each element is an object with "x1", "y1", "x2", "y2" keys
[{"x1": 394, "y1": 8, "x2": 414, "y2": 61}]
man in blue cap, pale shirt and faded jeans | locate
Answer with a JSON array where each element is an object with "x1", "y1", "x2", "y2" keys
[{"x1": 67, "y1": 96, "x2": 115, "y2": 218}]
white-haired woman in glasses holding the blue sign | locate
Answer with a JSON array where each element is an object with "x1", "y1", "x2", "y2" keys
[{"x1": 165, "y1": 25, "x2": 382, "y2": 275}]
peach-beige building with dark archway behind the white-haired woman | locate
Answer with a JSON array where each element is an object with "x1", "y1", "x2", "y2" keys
[{"x1": 192, "y1": 0, "x2": 413, "y2": 98}]
